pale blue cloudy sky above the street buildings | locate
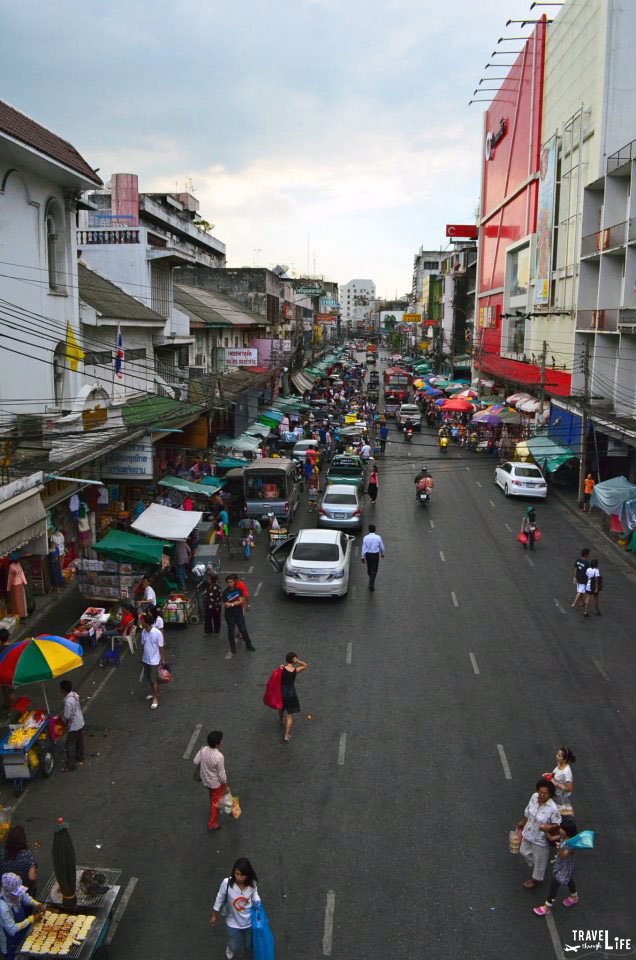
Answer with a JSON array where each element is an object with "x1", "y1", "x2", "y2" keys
[{"x1": 0, "y1": 0, "x2": 540, "y2": 297}]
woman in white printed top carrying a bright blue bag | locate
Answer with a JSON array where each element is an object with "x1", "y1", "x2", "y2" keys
[{"x1": 210, "y1": 857, "x2": 261, "y2": 960}]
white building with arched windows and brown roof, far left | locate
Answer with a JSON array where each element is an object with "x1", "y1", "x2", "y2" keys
[{"x1": 0, "y1": 101, "x2": 101, "y2": 414}]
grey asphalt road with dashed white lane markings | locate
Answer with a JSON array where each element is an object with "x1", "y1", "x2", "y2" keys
[{"x1": 4, "y1": 364, "x2": 636, "y2": 960}]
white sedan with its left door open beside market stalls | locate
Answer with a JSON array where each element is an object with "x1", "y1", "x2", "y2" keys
[{"x1": 268, "y1": 529, "x2": 354, "y2": 597}]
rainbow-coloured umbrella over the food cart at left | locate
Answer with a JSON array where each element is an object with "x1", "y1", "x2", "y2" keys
[{"x1": 0, "y1": 634, "x2": 84, "y2": 710}]
